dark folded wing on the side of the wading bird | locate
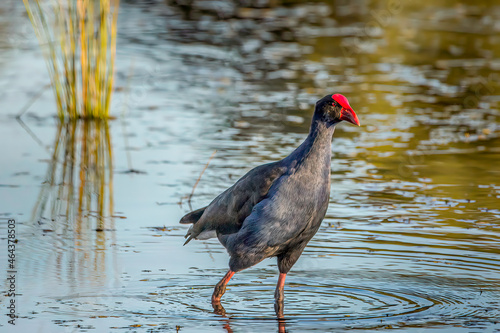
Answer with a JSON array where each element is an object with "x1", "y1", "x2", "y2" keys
[{"x1": 181, "y1": 161, "x2": 287, "y2": 244}]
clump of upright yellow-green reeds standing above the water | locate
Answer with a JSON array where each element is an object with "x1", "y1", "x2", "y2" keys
[{"x1": 23, "y1": 0, "x2": 119, "y2": 120}]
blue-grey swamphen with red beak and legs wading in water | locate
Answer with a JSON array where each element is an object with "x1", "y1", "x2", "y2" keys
[{"x1": 180, "y1": 94, "x2": 359, "y2": 311}]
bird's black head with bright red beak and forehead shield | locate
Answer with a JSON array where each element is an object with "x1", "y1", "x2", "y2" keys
[{"x1": 314, "y1": 94, "x2": 359, "y2": 126}]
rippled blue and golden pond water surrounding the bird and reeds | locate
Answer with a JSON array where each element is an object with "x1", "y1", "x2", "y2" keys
[{"x1": 0, "y1": 0, "x2": 500, "y2": 332}]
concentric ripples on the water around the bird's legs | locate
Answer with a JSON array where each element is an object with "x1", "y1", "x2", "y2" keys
[{"x1": 41, "y1": 270, "x2": 500, "y2": 328}]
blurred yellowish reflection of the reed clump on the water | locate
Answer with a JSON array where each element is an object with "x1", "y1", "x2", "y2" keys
[{"x1": 30, "y1": 120, "x2": 116, "y2": 286}]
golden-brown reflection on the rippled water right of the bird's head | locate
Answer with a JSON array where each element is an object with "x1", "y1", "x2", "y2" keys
[{"x1": 292, "y1": 1, "x2": 500, "y2": 246}]
